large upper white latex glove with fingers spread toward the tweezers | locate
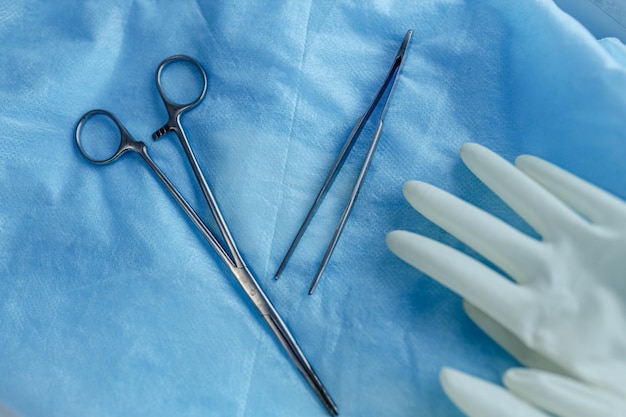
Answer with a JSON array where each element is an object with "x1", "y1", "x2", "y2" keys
[{"x1": 387, "y1": 144, "x2": 626, "y2": 395}]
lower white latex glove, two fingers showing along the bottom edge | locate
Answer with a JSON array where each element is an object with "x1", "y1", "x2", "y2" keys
[{"x1": 440, "y1": 368, "x2": 626, "y2": 417}]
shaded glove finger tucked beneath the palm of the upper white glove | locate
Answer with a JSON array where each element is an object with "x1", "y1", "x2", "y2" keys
[{"x1": 463, "y1": 300, "x2": 567, "y2": 374}]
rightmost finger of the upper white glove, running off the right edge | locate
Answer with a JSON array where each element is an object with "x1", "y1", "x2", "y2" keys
[{"x1": 515, "y1": 155, "x2": 626, "y2": 224}]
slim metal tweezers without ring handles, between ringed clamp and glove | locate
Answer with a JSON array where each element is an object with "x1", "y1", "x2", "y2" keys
[{"x1": 274, "y1": 30, "x2": 413, "y2": 294}]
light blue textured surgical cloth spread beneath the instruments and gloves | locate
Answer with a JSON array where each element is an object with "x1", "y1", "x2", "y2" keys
[{"x1": 0, "y1": 0, "x2": 626, "y2": 417}]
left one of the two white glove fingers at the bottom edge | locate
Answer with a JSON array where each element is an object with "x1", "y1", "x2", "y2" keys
[{"x1": 439, "y1": 368, "x2": 548, "y2": 417}]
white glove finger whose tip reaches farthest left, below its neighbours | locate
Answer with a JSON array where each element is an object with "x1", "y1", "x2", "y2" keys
[{"x1": 387, "y1": 230, "x2": 530, "y2": 329}]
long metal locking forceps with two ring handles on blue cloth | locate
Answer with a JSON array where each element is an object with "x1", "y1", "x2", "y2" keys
[{"x1": 75, "y1": 55, "x2": 338, "y2": 416}]
